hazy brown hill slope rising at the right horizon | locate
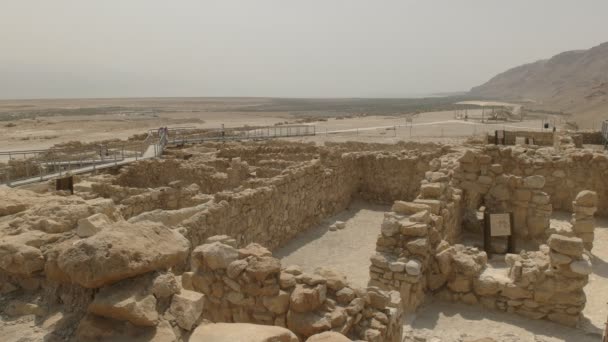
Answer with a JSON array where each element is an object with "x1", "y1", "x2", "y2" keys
[{"x1": 469, "y1": 42, "x2": 608, "y2": 127}]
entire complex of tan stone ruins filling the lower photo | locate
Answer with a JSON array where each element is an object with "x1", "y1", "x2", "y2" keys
[{"x1": 0, "y1": 142, "x2": 608, "y2": 342}]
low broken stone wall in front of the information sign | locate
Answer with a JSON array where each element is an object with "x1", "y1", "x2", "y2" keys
[{"x1": 437, "y1": 234, "x2": 591, "y2": 326}]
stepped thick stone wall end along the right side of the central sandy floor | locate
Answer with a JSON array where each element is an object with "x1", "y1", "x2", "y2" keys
[{"x1": 370, "y1": 156, "x2": 462, "y2": 312}]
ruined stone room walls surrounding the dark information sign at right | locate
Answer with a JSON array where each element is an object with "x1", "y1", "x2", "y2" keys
[{"x1": 370, "y1": 146, "x2": 603, "y2": 326}]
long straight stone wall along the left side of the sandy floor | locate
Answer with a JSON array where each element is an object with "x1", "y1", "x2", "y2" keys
[{"x1": 182, "y1": 160, "x2": 357, "y2": 249}]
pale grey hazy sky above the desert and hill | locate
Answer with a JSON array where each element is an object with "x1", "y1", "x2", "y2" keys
[{"x1": 0, "y1": 0, "x2": 608, "y2": 99}]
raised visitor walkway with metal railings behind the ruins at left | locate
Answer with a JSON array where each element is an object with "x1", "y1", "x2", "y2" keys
[{"x1": 0, "y1": 125, "x2": 316, "y2": 186}]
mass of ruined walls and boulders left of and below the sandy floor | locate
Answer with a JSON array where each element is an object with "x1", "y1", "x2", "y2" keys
[{"x1": 0, "y1": 143, "x2": 450, "y2": 341}]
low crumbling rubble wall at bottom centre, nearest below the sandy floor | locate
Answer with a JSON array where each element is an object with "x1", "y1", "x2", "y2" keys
[{"x1": 182, "y1": 236, "x2": 402, "y2": 342}]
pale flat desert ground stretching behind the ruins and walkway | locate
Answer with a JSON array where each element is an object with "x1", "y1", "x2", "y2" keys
[{"x1": 0, "y1": 98, "x2": 552, "y2": 151}]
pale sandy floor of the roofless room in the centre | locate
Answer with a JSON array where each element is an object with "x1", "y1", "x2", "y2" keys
[{"x1": 273, "y1": 201, "x2": 389, "y2": 287}]
